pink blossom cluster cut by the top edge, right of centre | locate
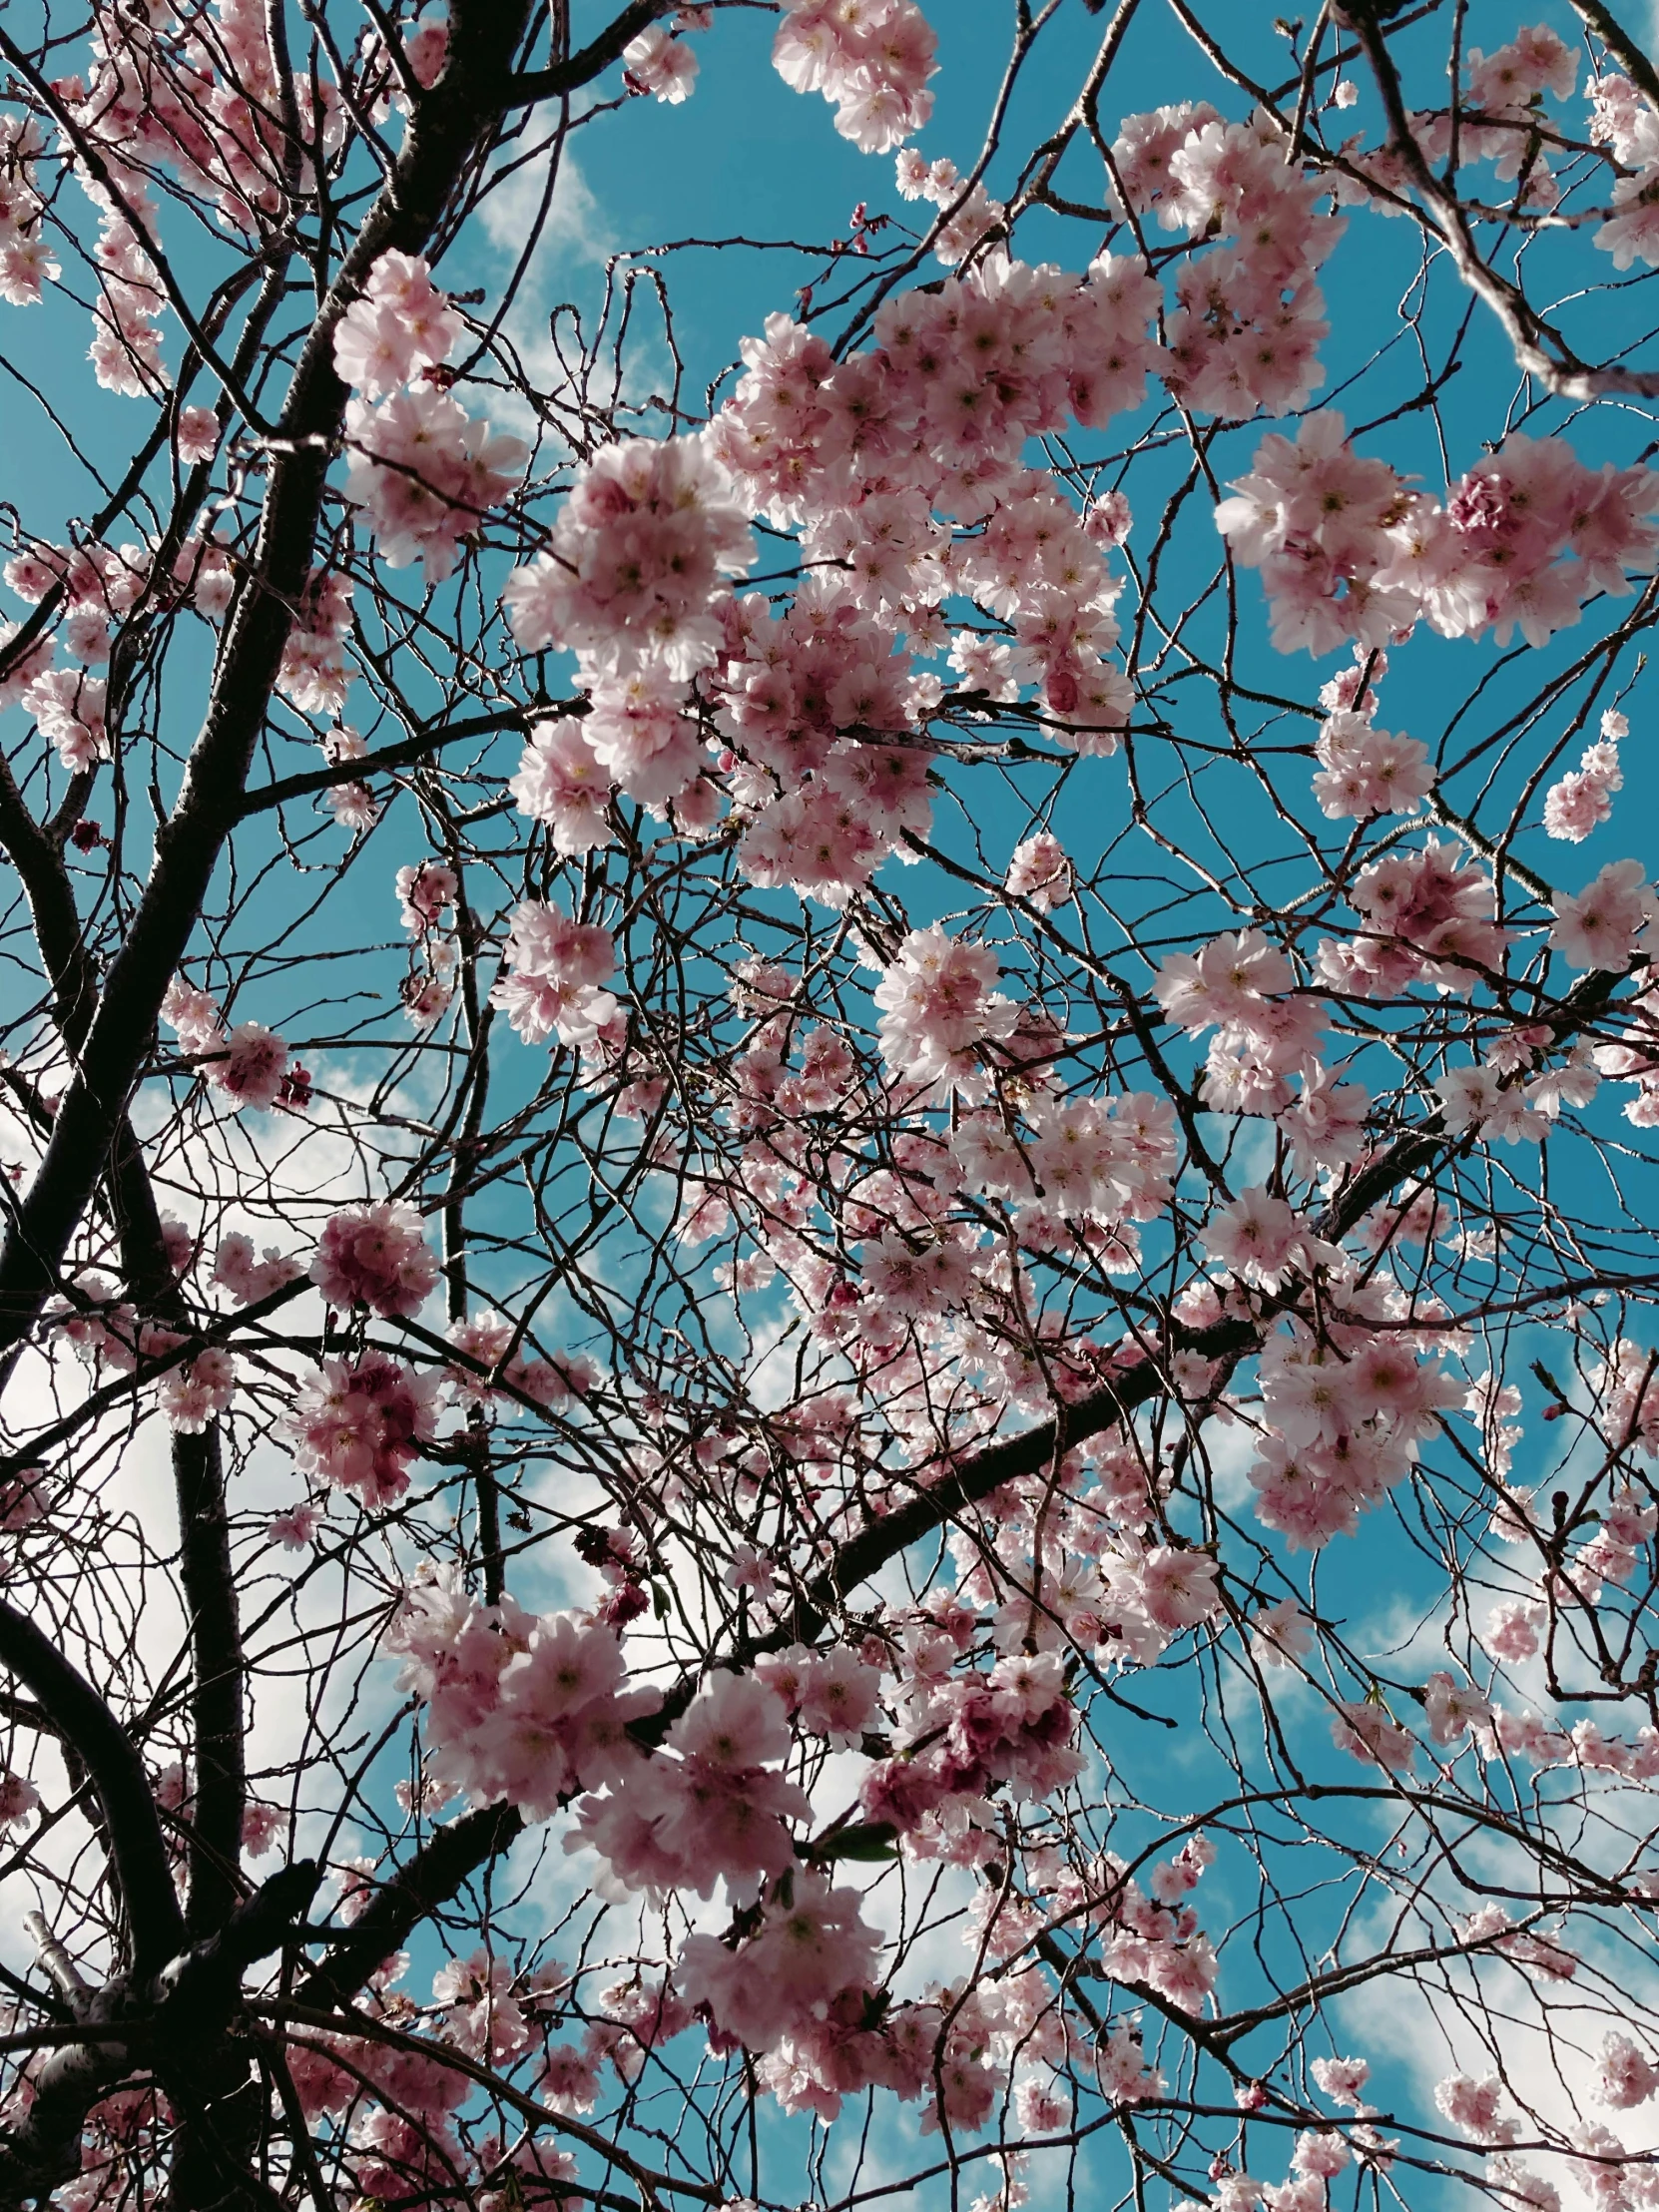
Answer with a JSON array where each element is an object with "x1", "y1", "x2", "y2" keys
[{"x1": 772, "y1": 0, "x2": 938, "y2": 153}]
